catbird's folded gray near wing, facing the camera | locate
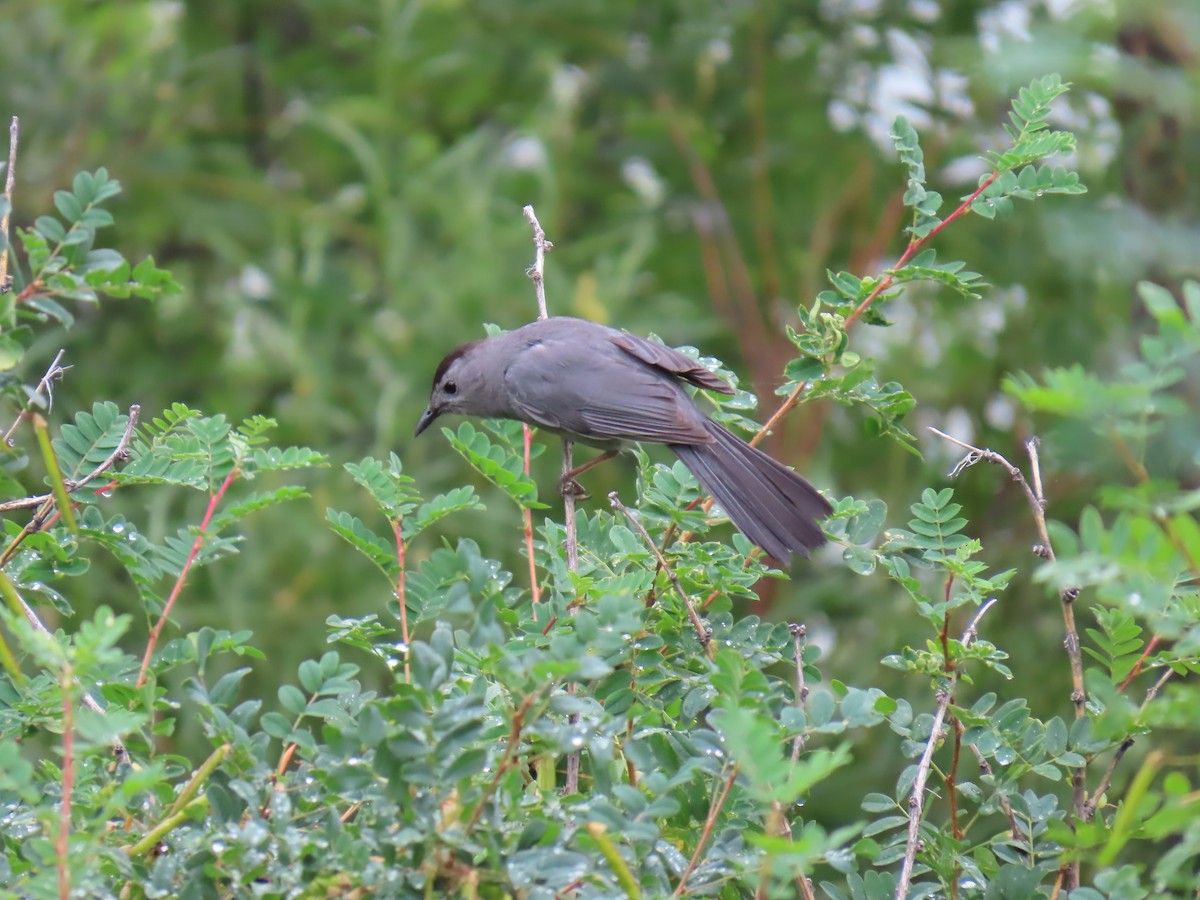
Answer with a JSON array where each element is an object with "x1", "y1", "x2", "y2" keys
[{"x1": 504, "y1": 338, "x2": 712, "y2": 444}]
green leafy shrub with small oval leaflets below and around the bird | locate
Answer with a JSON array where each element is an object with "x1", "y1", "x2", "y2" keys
[{"x1": 0, "y1": 66, "x2": 1200, "y2": 899}]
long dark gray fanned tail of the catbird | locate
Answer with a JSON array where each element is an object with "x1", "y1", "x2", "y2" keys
[{"x1": 671, "y1": 419, "x2": 833, "y2": 563}]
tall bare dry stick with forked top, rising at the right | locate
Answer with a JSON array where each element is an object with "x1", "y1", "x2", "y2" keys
[{"x1": 930, "y1": 427, "x2": 1087, "y2": 892}]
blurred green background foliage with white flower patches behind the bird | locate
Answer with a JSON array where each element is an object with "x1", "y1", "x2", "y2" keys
[{"x1": 0, "y1": 0, "x2": 1200, "y2": 816}]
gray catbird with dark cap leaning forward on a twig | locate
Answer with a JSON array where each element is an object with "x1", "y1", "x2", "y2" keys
[{"x1": 416, "y1": 316, "x2": 832, "y2": 562}]
